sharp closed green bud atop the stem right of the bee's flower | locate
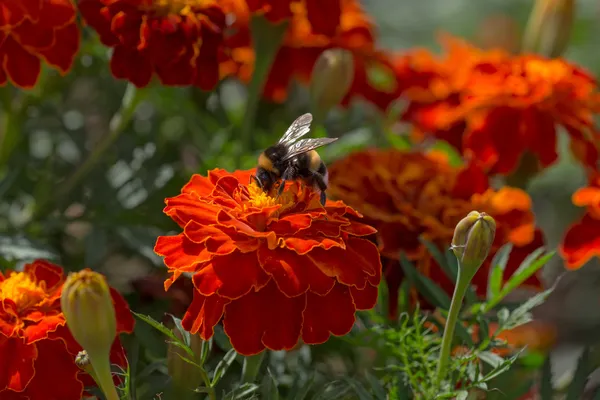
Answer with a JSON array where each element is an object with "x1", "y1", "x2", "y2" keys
[{"x1": 452, "y1": 211, "x2": 496, "y2": 274}]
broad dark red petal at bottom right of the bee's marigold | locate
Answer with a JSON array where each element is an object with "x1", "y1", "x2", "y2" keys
[{"x1": 302, "y1": 284, "x2": 356, "y2": 344}]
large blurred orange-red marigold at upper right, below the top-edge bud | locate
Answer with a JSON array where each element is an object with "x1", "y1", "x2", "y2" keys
[{"x1": 396, "y1": 36, "x2": 600, "y2": 174}]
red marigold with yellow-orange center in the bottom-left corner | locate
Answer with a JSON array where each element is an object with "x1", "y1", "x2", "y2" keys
[{"x1": 0, "y1": 260, "x2": 134, "y2": 400}]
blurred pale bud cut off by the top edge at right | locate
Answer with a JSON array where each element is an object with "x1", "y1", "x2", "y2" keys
[{"x1": 523, "y1": 0, "x2": 575, "y2": 57}]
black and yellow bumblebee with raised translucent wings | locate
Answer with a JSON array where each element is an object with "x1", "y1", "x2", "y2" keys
[{"x1": 251, "y1": 113, "x2": 337, "y2": 206}]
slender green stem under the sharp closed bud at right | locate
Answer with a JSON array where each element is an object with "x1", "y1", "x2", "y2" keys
[{"x1": 436, "y1": 265, "x2": 473, "y2": 388}]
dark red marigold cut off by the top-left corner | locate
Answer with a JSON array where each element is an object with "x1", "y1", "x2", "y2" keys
[{"x1": 0, "y1": 0, "x2": 79, "y2": 89}]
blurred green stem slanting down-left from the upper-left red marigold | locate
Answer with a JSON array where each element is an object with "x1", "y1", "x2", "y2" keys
[{"x1": 32, "y1": 84, "x2": 147, "y2": 221}]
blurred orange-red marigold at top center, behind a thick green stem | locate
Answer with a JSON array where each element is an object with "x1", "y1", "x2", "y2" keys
[{"x1": 224, "y1": 0, "x2": 397, "y2": 102}]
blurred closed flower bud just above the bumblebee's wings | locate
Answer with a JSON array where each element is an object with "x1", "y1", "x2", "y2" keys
[{"x1": 310, "y1": 48, "x2": 354, "y2": 120}]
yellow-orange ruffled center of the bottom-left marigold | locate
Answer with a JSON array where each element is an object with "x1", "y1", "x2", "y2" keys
[{"x1": 0, "y1": 272, "x2": 46, "y2": 312}]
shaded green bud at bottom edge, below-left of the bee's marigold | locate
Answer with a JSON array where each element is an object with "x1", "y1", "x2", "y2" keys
[{"x1": 167, "y1": 329, "x2": 202, "y2": 399}]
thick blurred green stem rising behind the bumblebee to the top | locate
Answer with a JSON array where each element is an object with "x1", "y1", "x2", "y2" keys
[{"x1": 237, "y1": 15, "x2": 288, "y2": 165}]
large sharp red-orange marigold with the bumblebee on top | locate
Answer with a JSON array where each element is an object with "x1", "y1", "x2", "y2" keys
[{"x1": 154, "y1": 169, "x2": 381, "y2": 355}]
